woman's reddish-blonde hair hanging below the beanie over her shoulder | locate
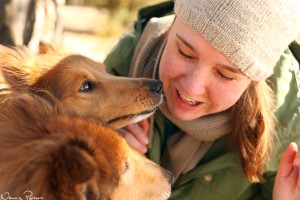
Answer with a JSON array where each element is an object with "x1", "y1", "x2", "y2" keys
[{"x1": 229, "y1": 81, "x2": 275, "y2": 182}]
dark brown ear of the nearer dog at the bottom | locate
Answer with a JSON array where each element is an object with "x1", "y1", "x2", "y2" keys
[{"x1": 54, "y1": 142, "x2": 99, "y2": 199}]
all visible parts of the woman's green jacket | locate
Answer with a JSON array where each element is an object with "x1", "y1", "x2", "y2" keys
[{"x1": 104, "y1": 2, "x2": 300, "y2": 200}]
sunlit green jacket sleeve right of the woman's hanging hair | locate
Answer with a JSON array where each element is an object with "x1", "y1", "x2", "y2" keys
[{"x1": 248, "y1": 43, "x2": 300, "y2": 200}]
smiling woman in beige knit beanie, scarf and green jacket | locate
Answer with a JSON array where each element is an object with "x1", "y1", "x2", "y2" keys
[{"x1": 104, "y1": 0, "x2": 300, "y2": 200}]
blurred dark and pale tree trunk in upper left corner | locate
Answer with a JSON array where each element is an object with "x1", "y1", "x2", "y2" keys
[{"x1": 0, "y1": 0, "x2": 65, "y2": 52}]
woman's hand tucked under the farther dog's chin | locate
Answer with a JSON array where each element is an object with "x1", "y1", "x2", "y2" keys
[{"x1": 117, "y1": 119, "x2": 149, "y2": 154}]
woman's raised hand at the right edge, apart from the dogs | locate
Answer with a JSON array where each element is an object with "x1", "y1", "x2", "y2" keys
[{"x1": 273, "y1": 142, "x2": 300, "y2": 200}]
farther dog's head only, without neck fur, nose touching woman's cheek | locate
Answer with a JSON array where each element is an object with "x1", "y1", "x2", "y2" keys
[{"x1": 33, "y1": 52, "x2": 162, "y2": 128}]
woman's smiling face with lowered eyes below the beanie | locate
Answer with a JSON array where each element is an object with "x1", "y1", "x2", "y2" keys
[{"x1": 159, "y1": 18, "x2": 251, "y2": 120}]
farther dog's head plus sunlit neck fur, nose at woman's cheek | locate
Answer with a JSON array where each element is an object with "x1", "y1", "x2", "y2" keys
[{"x1": 0, "y1": 45, "x2": 162, "y2": 128}]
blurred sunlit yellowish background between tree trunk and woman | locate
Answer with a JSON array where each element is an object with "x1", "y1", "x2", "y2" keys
[{"x1": 61, "y1": 0, "x2": 162, "y2": 61}]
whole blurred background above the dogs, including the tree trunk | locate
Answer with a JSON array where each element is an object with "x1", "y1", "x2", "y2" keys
[{"x1": 0, "y1": 0, "x2": 164, "y2": 61}]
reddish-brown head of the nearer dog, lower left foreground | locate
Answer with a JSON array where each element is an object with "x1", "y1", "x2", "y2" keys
[{"x1": 0, "y1": 94, "x2": 172, "y2": 200}]
